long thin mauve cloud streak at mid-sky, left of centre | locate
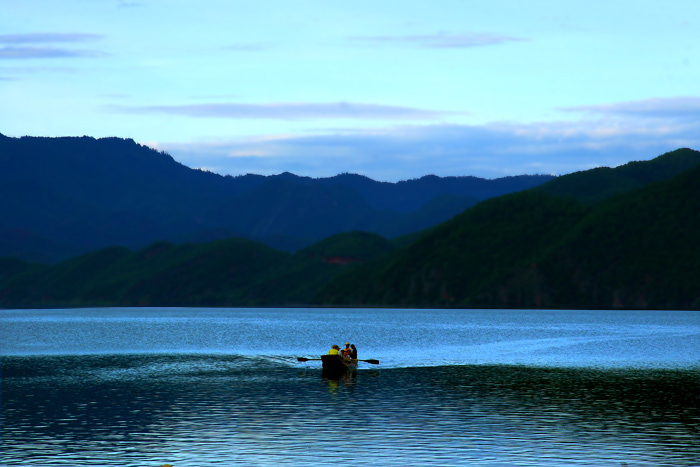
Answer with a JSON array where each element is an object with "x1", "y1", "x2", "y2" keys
[{"x1": 112, "y1": 102, "x2": 449, "y2": 120}]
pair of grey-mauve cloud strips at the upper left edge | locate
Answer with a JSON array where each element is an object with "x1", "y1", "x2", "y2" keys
[{"x1": 0, "y1": 33, "x2": 107, "y2": 60}]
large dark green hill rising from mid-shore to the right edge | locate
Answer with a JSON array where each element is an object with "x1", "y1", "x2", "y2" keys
[{"x1": 318, "y1": 149, "x2": 700, "y2": 309}]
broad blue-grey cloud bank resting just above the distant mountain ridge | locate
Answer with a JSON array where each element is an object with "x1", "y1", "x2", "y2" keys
[{"x1": 159, "y1": 116, "x2": 700, "y2": 181}]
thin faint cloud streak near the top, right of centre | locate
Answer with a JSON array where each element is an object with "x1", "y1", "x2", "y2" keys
[{"x1": 351, "y1": 33, "x2": 527, "y2": 49}]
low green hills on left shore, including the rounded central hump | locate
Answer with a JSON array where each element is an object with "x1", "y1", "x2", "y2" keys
[{"x1": 0, "y1": 232, "x2": 393, "y2": 308}]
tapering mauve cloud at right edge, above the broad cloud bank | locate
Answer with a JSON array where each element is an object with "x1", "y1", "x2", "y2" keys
[{"x1": 560, "y1": 97, "x2": 700, "y2": 120}]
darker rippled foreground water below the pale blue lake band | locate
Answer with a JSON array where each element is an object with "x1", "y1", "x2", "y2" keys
[{"x1": 1, "y1": 355, "x2": 700, "y2": 466}]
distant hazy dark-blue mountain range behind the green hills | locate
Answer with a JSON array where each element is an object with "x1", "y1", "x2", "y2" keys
[{"x1": 0, "y1": 134, "x2": 552, "y2": 262}]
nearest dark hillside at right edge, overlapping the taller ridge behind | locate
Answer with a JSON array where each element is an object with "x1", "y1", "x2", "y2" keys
[{"x1": 528, "y1": 163, "x2": 700, "y2": 309}]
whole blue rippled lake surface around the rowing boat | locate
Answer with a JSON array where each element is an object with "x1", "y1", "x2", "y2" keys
[{"x1": 0, "y1": 308, "x2": 700, "y2": 467}]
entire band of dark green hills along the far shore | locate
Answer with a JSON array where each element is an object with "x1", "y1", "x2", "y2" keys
[{"x1": 0, "y1": 133, "x2": 700, "y2": 309}]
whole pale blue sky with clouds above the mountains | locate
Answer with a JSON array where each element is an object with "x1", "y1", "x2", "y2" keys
[{"x1": 0, "y1": 0, "x2": 700, "y2": 182}]
